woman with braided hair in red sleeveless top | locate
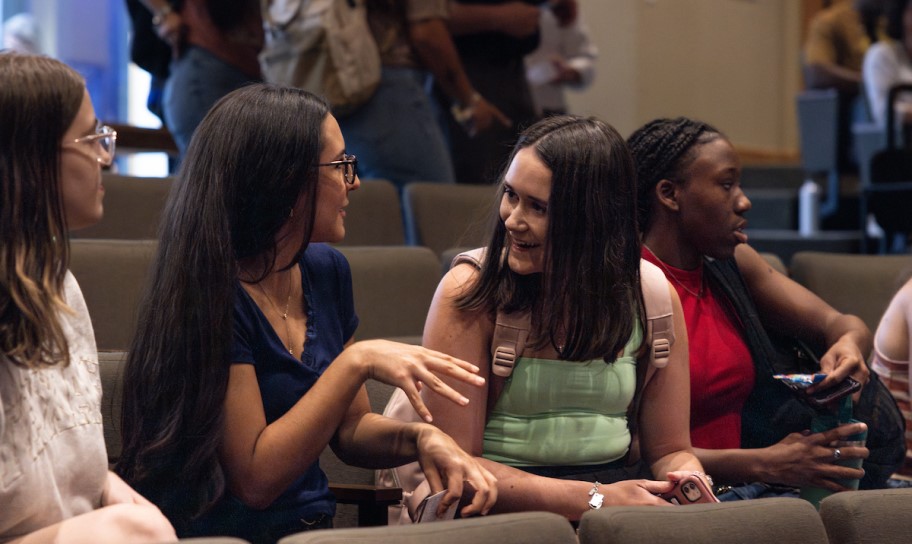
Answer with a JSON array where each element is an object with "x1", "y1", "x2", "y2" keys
[{"x1": 628, "y1": 117, "x2": 871, "y2": 500}]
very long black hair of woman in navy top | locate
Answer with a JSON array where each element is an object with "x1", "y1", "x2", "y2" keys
[{"x1": 117, "y1": 84, "x2": 329, "y2": 527}]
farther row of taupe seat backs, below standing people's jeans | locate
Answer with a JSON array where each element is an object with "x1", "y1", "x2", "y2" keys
[{"x1": 73, "y1": 173, "x2": 494, "y2": 255}]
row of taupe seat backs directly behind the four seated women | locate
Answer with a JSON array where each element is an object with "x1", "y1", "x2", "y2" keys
[{"x1": 70, "y1": 235, "x2": 912, "y2": 350}]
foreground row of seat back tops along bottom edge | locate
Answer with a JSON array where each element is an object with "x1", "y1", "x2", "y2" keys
[{"x1": 134, "y1": 489, "x2": 912, "y2": 544}]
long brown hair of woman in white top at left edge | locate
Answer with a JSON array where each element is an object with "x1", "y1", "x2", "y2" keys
[{"x1": 0, "y1": 53, "x2": 85, "y2": 368}]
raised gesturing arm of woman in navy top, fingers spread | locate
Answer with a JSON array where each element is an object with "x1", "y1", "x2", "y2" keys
[{"x1": 219, "y1": 340, "x2": 481, "y2": 508}]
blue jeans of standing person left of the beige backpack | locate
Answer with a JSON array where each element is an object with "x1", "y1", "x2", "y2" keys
[{"x1": 164, "y1": 46, "x2": 257, "y2": 157}]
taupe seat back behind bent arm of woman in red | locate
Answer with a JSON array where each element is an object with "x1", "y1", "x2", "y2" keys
[{"x1": 789, "y1": 251, "x2": 912, "y2": 331}]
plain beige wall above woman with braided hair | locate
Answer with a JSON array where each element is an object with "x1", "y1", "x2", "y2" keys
[{"x1": 568, "y1": 0, "x2": 801, "y2": 154}]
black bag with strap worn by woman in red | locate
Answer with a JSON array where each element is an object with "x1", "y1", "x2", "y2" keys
[{"x1": 706, "y1": 259, "x2": 906, "y2": 489}]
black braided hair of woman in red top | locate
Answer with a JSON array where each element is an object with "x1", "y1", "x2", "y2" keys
[{"x1": 627, "y1": 117, "x2": 724, "y2": 233}]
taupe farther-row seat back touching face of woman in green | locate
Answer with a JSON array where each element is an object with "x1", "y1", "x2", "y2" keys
[{"x1": 402, "y1": 183, "x2": 497, "y2": 255}]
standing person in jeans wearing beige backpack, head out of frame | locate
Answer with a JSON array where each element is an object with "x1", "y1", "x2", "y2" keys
[{"x1": 338, "y1": 0, "x2": 510, "y2": 188}]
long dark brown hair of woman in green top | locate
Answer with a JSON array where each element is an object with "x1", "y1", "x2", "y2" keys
[{"x1": 457, "y1": 115, "x2": 643, "y2": 361}]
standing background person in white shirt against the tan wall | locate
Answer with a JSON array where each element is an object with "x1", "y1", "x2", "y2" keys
[{"x1": 526, "y1": 4, "x2": 598, "y2": 117}]
